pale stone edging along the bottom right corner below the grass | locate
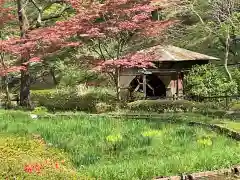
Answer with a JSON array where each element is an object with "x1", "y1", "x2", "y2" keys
[{"x1": 154, "y1": 165, "x2": 240, "y2": 180}]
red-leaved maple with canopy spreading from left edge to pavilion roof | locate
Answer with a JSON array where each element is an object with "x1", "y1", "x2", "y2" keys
[{"x1": 0, "y1": 0, "x2": 177, "y2": 103}]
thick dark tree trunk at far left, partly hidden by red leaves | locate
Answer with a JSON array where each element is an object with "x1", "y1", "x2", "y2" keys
[{"x1": 17, "y1": 0, "x2": 32, "y2": 109}]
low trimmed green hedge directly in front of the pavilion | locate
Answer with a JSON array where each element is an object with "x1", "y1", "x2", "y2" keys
[{"x1": 128, "y1": 100, "x2": 194, "y2": 112}]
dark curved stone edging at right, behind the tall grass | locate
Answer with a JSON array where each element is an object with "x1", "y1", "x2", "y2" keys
[{"x1": 188, "y1": 122, "x2": 240, "y2": 141}]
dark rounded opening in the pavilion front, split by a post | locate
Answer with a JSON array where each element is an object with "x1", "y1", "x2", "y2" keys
[{"x1": 130, "y1": 74, "x2": 166, "y2": 98}]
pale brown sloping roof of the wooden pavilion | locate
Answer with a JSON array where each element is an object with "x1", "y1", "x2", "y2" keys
[{"x1": 140, "y1": 45, "x2": 219, "y2": 61}]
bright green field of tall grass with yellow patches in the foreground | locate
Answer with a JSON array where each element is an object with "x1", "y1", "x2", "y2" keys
[{"x1": 0, "y1": 111, "x2": 240, "y2": 180}]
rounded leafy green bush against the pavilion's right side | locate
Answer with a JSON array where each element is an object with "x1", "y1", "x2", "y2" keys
[{"x1": 185, "y1": 64, "x2": 238, "y2": 97}]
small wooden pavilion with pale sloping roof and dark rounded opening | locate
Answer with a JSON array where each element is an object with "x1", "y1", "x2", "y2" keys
[{"x1": 119, "y1": 45, "x2": 218, "y2": 99}]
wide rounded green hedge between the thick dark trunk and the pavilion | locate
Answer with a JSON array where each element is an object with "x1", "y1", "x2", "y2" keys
[{"x1": 31, "y1": 88, "x2": 115, "y2": 112}]
